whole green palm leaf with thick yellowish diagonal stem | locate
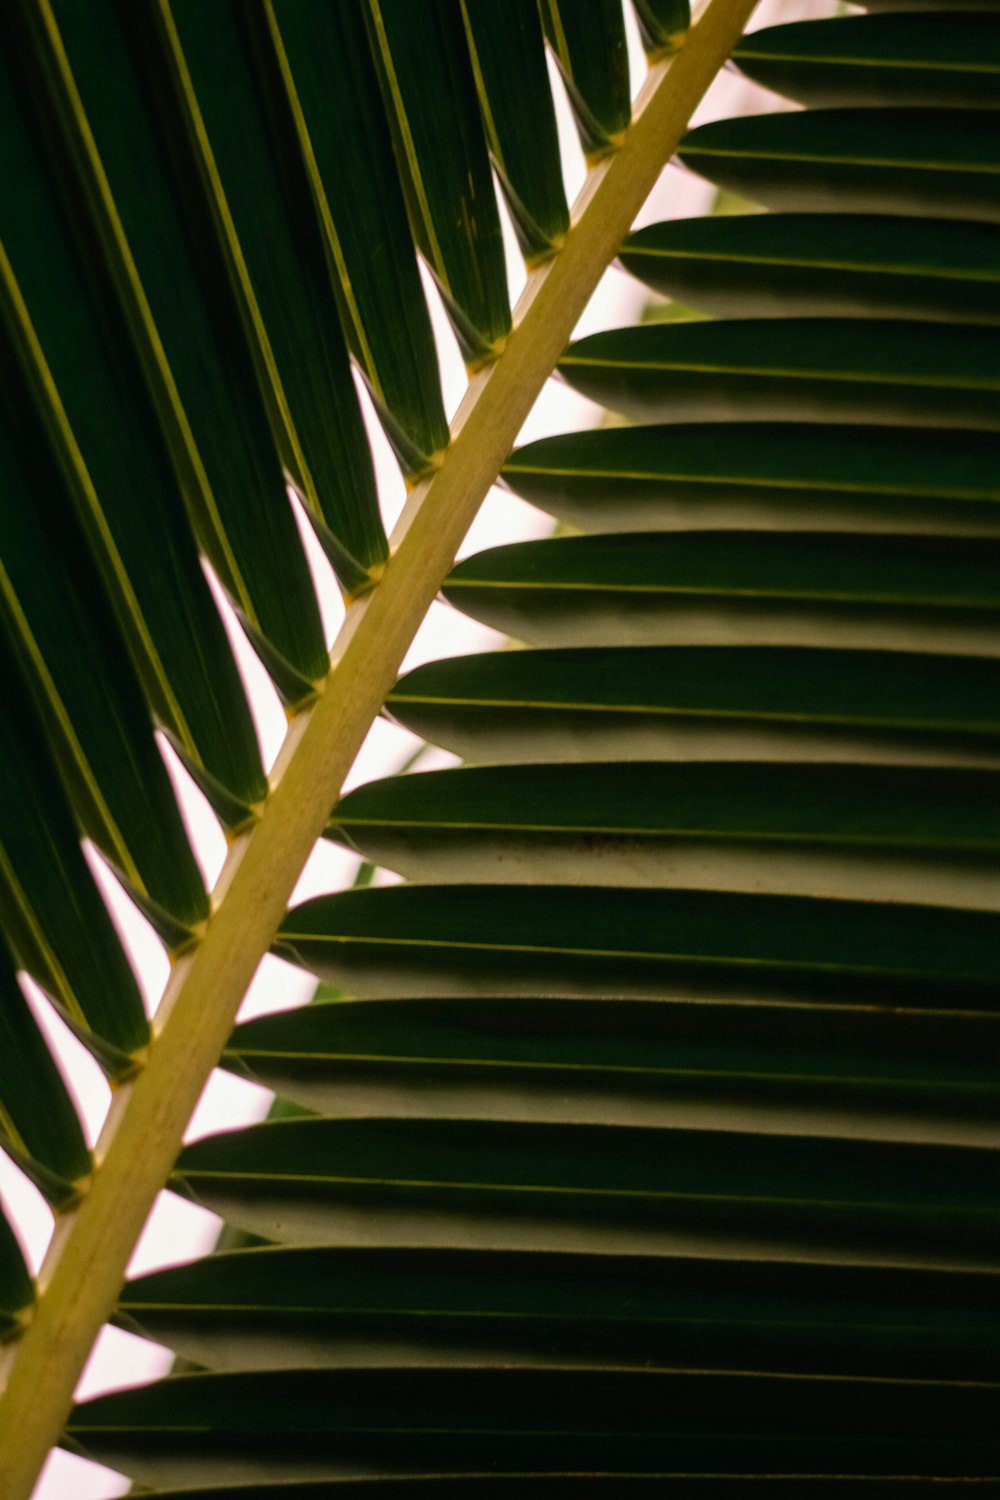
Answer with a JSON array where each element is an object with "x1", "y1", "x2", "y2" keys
[{"x1": 0, "y1": 0, "x2": 1000, "y2": 1500}]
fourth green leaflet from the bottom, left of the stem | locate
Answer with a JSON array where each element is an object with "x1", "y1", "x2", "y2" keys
[{"x1": 0, "y1": 300, "x2": 208, "y2": 947}]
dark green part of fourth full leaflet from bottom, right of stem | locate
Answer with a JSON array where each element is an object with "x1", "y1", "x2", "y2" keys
[{"x1": 226, "y1": 992, "x2": 1000, "y2": 1098}]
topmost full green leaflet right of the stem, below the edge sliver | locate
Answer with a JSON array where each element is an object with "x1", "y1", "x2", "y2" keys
[{"x1": 733, "y1": 6, "x2": 1000, "y2": 110}]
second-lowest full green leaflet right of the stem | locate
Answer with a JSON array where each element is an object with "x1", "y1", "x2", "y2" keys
[{"x1": 121, "y1": 1247, "x2": 1000, "y2": 1379}]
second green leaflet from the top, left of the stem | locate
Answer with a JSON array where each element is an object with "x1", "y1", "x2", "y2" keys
[{"x1": 538, "y1": 0, "x2": 631, "y2": 161}]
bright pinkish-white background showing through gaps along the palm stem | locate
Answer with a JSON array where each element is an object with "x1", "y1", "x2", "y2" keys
[{"x1": 0, "y1": 0, "x2": 837, "y2": 1500}]
